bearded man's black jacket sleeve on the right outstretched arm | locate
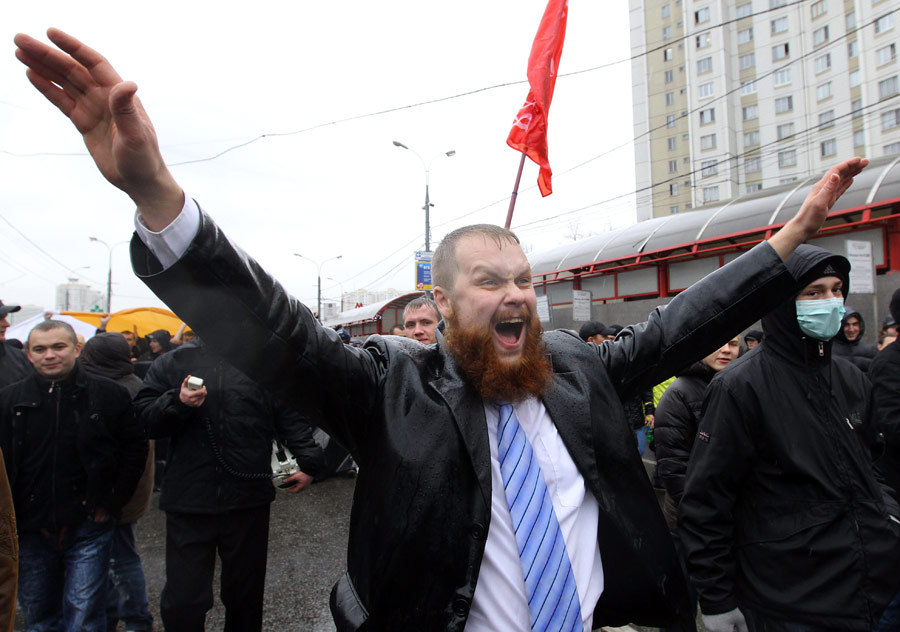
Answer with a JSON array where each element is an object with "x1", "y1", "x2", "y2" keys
[{"x1": 597, "y1": 242, "x2": 796, "y2": 399}]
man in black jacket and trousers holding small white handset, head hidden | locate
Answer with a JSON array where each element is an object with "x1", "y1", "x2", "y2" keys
[{"x1": 135, "y1": 338, "x2": 323, "y2": 632}]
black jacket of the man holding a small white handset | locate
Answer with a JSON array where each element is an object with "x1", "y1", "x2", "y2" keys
[{"x1": 134, "y1": 340, "x2": 323, "y2": 514}]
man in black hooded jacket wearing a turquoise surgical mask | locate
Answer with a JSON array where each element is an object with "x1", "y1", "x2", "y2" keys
[{"x1": 680, "y1": 245, "x2": 900, "y2": 632}]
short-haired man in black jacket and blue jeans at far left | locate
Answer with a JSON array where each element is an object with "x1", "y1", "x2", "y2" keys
[{"x1": 0, "y1": 320, "x2": 147, "y2": 632}]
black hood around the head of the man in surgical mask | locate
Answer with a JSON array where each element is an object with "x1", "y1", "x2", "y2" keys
[{"x1": 762, "y1": 244, "x2": 850, "y2": 363}]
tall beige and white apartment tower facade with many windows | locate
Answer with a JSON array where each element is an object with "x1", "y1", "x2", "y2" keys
[{"x1": 630, "y1": 0, "x2": 900, "y2": 219}]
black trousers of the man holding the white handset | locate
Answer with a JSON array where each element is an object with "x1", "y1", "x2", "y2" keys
[{"x1": 160, "y1": 504, "x2": 269, "y2": 632}]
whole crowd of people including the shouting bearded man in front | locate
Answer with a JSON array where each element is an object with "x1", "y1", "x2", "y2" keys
[{"x1": 0, "y1": 29, "x2": 900, "y2": 632}]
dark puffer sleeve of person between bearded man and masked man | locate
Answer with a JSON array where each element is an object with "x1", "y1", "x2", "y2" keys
[{"x1": 653, "y1": 387, "x2": 697, "y2": 507}]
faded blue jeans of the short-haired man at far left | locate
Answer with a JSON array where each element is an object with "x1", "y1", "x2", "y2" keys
[{"x1": 19, "y1": 520, "x2": 113, "y2": 632}]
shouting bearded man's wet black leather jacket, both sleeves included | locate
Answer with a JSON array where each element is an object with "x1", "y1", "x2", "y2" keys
[{"x1": 132, "y1": 210, "x2": 793, "y2": 631}]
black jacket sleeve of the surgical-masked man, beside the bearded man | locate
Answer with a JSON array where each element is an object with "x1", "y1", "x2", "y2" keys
[{"x1": 679, "y1": 375, "x2": 755, "y2": 614}]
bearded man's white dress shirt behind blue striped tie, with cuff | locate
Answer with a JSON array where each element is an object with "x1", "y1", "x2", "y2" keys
[{"x1": 135, "y1": 201, "x2": 603, "y2": 632}]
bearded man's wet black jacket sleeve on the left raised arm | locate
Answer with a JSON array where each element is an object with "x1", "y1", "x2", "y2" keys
[{"x1": 131, "y1": 214, "x2": 387, "y2": 452}]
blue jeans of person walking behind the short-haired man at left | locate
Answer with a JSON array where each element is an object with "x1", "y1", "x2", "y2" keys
[{"x1": 106, "y1": 522, "x2": 153, "y2": 630}]
